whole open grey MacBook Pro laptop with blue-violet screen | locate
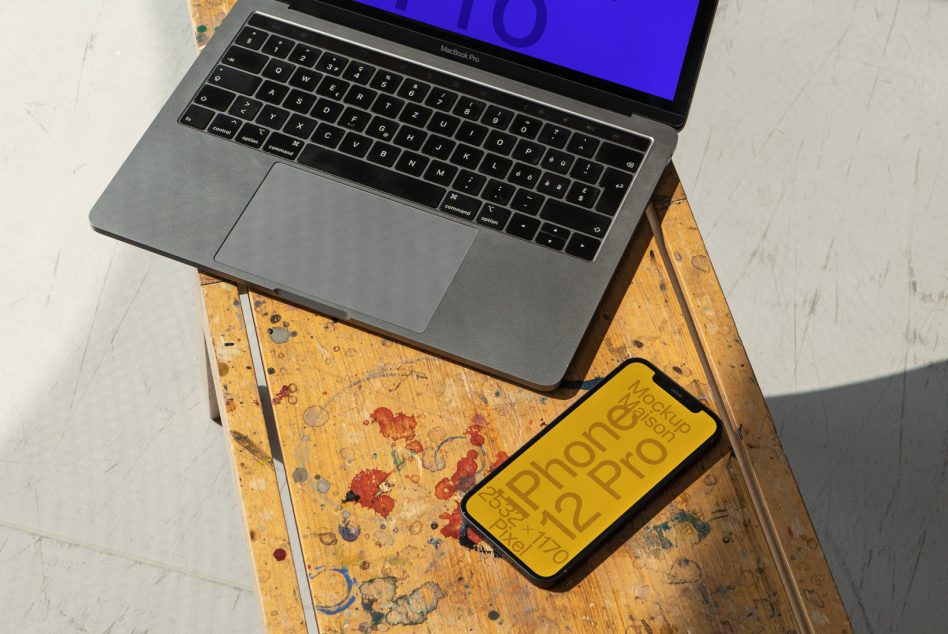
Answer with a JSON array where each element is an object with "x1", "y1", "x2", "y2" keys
[{"x1": 90, "y1": 0, "x2": 715, "y2": 389}]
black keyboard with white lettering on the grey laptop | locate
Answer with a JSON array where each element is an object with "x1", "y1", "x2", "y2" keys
[{"x1": 179, "y1": 14, "x2": 651, "y2": 260}]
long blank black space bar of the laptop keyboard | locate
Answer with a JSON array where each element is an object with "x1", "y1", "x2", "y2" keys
[{"x1": 300, "y1": 144, "x2": 445, "y2": 209}]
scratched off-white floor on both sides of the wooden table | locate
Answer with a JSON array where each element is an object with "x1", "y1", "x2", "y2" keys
[{"x1": 0, "y1": 0, "x2": 948, "y2": 632}]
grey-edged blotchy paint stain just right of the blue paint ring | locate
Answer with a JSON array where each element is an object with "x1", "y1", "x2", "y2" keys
[{"x1": 359, "y1": 577, "x2": 445, "y2": 630}]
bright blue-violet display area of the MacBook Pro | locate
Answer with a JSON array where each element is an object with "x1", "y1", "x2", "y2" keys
[{"x1": 355, "y1": 0, "x2": 699, "y2": 101}]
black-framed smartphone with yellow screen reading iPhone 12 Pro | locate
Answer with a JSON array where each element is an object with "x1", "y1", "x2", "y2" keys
[{"x1": 461, "y1": 359, "x2": 721, "y2": 587}]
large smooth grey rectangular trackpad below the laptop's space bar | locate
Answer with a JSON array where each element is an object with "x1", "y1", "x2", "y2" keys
[{"x1": 214, "y1": 163, "x2": 477, "y2": 332}]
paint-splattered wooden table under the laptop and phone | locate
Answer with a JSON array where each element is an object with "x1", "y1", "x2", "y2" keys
[{"x1": 191, "y1": 0, "x2": 850, "y2": 633}]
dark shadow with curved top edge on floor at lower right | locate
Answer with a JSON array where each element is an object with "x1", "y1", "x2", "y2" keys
[{"x1": 767, "y1": 362, "x2": 948, "y2": 633}]
